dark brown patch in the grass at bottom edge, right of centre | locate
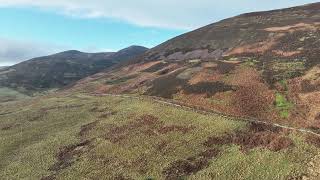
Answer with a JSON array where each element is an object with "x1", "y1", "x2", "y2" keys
[{"x1": 162, "y1": 148, "x2": 220, "y2": 180}]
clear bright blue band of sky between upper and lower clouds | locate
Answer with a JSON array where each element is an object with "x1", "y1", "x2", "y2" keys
[{"x1": 0, "y1": 8, "x2": 184, "y2": 51}]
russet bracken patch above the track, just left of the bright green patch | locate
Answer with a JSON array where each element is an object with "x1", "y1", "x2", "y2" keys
[{"x1": 227, "y1": 67, "x2": 274, "y2": 119}]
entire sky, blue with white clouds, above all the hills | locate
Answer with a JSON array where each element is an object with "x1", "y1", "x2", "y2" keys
[{"x1": 0, "y1": 0, "x2": 317, "y2": 66}]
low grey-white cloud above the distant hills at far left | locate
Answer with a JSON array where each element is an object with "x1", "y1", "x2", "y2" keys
[{"x1": 0, "y1": 38, "x2": 64, "y2": 66}]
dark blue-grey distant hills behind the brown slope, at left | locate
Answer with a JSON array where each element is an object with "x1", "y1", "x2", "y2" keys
[{"x1": 0, "y1": 46, "x2": 147, "y2": 91}]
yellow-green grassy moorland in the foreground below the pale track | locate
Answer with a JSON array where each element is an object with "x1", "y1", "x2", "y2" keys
[{"x1": 0, "y1": 94, "x2": 320, "y2": 179}]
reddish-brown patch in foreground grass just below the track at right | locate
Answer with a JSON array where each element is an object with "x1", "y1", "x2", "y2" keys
[{"x1": 204, "y1": 123, "x2": 294, "y2": 152}]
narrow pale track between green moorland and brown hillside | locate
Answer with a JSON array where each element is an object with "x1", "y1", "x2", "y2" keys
[{"x1": 90, "y1": 94, "x2": 320, "y2": 137}]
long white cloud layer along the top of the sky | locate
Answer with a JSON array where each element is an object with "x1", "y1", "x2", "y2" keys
[{"x1": 0, "y1": 0, "x2": 316, "y2": 29}]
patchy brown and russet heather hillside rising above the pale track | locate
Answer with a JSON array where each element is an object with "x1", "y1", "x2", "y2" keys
[{"x1": 70, "y1": 3, "x2": 320, "y2": 132}]
